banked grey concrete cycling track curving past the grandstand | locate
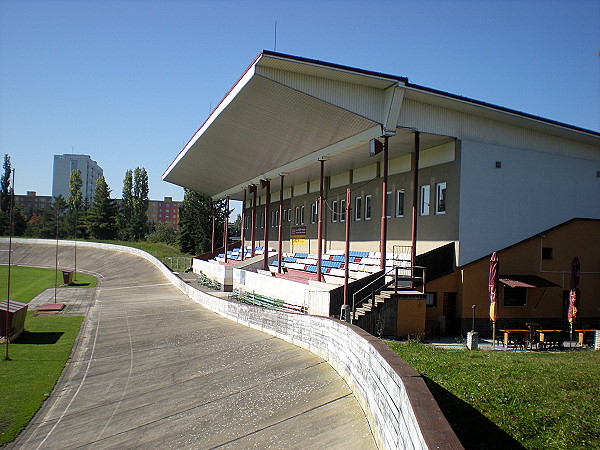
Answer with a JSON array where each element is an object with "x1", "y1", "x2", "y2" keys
[{"x1": 11, "y1": 244, "x2": 375, "y2": 449}]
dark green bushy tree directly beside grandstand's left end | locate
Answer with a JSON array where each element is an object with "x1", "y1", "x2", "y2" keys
[{"x1": 179, "y1": 189, "x2": 224, "y2": 255}]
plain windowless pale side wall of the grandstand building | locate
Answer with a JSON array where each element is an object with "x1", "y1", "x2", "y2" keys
[{"x1": 458, "y1": 141, "x2": 600, "y2": 265}]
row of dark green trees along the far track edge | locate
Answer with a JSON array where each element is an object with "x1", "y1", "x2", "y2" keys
[{"x1": 0, "y1": 155, "x2": 240, "y2": 254}]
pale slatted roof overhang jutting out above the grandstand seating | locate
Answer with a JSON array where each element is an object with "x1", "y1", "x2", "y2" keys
[{"x1": 163, "y1": 52, "x2": 414, "y2": 198}]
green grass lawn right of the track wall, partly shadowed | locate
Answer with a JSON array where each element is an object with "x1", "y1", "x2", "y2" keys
[{"x1": 388, "y1": 342, "x2": 600, "y2": 449}]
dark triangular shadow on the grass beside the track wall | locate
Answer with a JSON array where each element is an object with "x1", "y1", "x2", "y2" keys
[{"x1": 423, "y1": 376, "x2": 525, "y2": 450}]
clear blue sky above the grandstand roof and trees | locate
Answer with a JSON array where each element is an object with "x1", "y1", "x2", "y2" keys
[{"x1": 0, "y1": 0, "x2": 600, "y2": 200}]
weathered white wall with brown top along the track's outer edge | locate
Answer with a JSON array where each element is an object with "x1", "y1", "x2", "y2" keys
[{"x1": 8, "y1": 239, "x2": 462, "y2": 449}]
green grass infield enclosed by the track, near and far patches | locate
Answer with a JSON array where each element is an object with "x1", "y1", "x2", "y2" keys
[{"x1": 0, "y1": 266, "x2": 96, "y2": 445}]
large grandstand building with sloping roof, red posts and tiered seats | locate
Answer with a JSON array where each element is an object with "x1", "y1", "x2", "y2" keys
[{"x1": 163, "y1": 51, "x2": 600, "y2": 334}]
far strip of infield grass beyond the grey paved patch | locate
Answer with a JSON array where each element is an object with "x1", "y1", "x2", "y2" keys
[{"x1": 0, "y1": 266, "x2": 97, "y2": 303}]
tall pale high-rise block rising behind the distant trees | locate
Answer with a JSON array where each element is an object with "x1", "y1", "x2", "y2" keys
[{"x1": 52, "y1": 154, "x2": 104, "y2": 204}]
